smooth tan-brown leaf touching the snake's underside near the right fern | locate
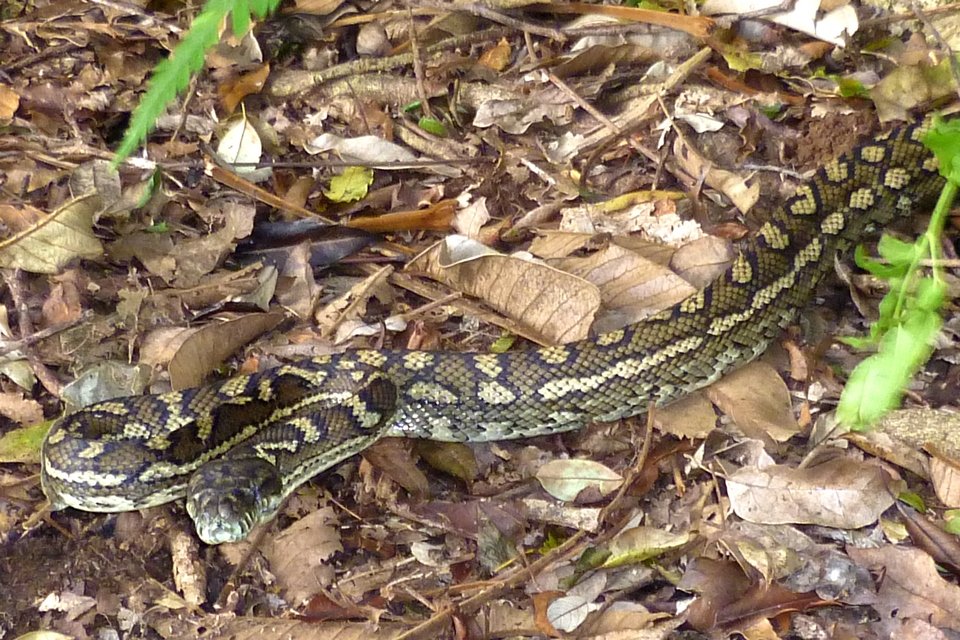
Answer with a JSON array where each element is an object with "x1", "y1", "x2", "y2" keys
[{"x1": 704, "y1": 361, "x2": 800, "y2": 442}]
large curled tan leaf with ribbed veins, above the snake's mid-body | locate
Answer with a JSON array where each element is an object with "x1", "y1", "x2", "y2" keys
[{"x1": 407, "y1": 235, "x2": 600, "y2": 344}]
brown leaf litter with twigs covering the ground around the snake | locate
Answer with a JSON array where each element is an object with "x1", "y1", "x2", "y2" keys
[{"x1": 0, "y1": 0, "x2": 960, "y2": 638}]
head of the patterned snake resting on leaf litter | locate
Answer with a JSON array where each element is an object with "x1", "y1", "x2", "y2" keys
[{"x1": 187, "y1": 458, "x2": 282, "y2": 544}]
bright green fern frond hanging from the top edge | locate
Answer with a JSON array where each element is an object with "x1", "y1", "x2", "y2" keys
[{"x1": 112, "y1": 0, "x2": 280, "y2": 168}]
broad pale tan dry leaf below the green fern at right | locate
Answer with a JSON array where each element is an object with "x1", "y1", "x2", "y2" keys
[{"x1": 726, "y1": 457, "x2": 897, "y2": 529}]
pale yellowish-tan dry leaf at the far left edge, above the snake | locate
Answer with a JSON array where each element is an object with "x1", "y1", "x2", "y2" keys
[{"x1": 0, "y1": 195, "x2": 103, "y2": 274}]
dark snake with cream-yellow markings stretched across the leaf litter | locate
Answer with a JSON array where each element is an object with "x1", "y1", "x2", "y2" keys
[{"x1": 41, "y1": 117, "x2": 944, "y2": 544}]
